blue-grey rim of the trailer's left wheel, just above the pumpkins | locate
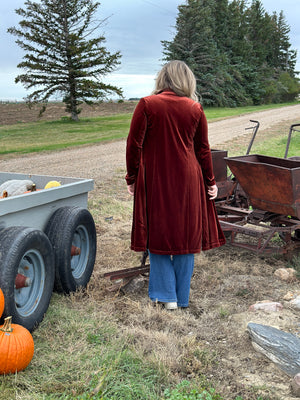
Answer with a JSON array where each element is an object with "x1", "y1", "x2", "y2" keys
[{"x1": 15, "y1": 249, "x2": 46, "y2": 316}]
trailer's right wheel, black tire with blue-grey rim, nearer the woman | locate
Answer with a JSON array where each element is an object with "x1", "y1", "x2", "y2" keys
[{"x1": 45, "y1": 206, "x2": 97, "y2": 294}]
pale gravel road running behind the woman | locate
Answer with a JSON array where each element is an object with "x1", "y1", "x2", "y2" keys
[{"x1": 0, "y1": 104, "x2": 300, "y2": 182}]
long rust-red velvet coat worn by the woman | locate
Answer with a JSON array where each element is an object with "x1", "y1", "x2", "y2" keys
[{"x1": 126, "y1": 90, "x2": 225, "y2": 255}]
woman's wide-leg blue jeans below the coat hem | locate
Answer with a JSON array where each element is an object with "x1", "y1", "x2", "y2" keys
[{"x1": 149, "y1": 252, "x2": 194, "y2": 307}]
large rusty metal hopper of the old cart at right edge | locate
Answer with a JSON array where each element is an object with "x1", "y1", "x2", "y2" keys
[{"x1": 225, "y1": 154, "x2": 300, "y2": 218}]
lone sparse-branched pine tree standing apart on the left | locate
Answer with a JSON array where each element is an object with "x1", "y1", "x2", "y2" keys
[{"x1": 8, "y1": 0, "x2": 122, "y2": 121}]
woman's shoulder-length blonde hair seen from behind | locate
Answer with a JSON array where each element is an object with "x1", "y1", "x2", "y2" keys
[{"x1": 152, "y1": 60, "x2": 198, "y2": 101}]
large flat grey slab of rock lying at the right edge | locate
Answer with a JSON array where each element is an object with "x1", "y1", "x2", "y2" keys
[{"x1": 247, "y1": 322, "x2": 300, "y2": 377}]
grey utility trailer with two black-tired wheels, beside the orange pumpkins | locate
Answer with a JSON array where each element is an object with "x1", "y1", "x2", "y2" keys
[{"x1": 0, "y1": 172, "x2": 96, "y2": 331}]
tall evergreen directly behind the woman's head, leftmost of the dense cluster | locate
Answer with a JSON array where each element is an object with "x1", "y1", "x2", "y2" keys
[{"x1": 162, "y1": 0, "x2": 246, "y2": 106}]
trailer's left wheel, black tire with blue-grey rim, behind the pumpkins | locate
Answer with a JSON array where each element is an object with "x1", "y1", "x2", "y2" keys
[{"x1": 0, "y1": 227, "x2": 54, "y2": 332}]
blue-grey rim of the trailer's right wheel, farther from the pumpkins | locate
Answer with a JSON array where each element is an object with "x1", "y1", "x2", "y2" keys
[{"x1": 71, "y1": 225, "x2": 90, "y2": 279}]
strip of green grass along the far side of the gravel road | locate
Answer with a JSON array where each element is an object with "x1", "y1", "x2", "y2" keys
[{"x1": 0, "y1": 103, "x2": 295, "y2": 154}]
